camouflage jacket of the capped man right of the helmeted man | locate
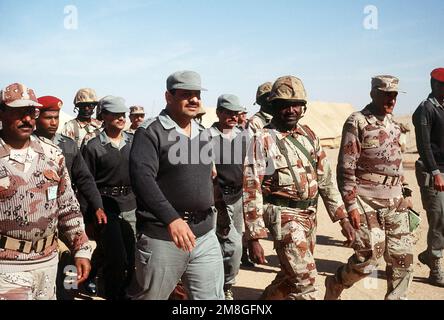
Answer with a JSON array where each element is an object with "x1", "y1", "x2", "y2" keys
[{"x1": 337, "y1": 105, "x2": 404, "y2": 212}]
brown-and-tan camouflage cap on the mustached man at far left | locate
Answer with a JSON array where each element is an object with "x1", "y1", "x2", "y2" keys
[{"x1": 0, "y1": 83, "x2": 42, "y2": 108}]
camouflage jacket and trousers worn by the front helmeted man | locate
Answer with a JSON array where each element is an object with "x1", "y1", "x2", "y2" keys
[{"x1": 243, "y1": 124, "x2": 346, "y2": 299}]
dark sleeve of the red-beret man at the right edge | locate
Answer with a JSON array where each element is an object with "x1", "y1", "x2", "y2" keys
[{"x1": 412, "y1": 102, "x2": 439, "y2": 173}]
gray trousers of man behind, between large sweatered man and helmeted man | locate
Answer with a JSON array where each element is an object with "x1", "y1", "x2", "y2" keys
[{"x1": 217, "y1": 197, "x2": 244, "y2": 285}]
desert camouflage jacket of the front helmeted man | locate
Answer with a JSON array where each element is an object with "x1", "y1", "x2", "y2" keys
[{"x1": 243, "y1": 123, "x2": 346, "y2": 239}]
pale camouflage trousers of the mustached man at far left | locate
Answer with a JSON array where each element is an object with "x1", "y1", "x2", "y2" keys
[{"x1": 0, "y1": 264, "x2": 57, "y2": 300}]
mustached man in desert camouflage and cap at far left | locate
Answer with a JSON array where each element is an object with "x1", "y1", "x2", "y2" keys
[{"x1": 0, "y1": 83, "x2": 92, "y2": 300}]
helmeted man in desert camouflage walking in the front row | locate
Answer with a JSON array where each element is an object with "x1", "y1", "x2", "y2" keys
[{"x1": 243, "y1": 76, "x2": 354, "y2": 300}]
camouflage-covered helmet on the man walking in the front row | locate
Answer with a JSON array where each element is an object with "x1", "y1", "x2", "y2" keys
[{"x1": 268, "y1": 76, "x2": 307, "y2": 102}]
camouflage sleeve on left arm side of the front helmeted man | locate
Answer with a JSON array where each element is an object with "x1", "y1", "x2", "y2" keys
[{"x1": 243, "y1": 132, "x2": 267, "y2": 240}]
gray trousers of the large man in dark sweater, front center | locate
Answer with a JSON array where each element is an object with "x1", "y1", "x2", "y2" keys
[{"x1": 128, "y1": 230, "x2": 225, "y2": 300}]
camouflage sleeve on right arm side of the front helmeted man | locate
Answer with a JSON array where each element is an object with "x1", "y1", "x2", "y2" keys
[{"x1": 316, "y1": 138, "x2": 347, "y2": 222}]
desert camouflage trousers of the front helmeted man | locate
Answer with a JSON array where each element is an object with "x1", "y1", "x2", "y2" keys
[{"x1": 261, "y1": 205, "x2": 318, "y2": 300}]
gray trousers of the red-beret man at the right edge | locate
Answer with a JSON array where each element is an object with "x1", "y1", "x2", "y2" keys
[{"x1": 416, "y1": 168, "x2": 444, "y2": 258}]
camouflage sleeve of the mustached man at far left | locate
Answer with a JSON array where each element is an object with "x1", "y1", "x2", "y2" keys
[{"x1": 57, "y1": 155, "x2": 92, "y2": 259}]
